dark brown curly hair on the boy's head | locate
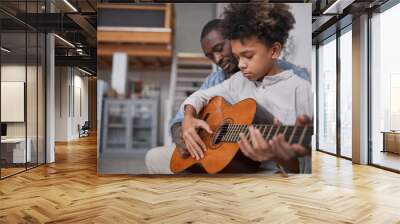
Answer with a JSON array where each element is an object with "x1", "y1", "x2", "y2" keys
[{"x1": 222, "y1": 1, "x2": 296, "y2": 46}]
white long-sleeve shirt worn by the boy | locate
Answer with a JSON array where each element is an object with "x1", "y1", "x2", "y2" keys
[{"x1": 180, "y1": 70, "x2": 313, "y2": 173}]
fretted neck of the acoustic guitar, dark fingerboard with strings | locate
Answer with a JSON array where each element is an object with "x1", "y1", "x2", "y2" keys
[{"x1": 215, "y1": 124, "x2": 313, "y2": 145}]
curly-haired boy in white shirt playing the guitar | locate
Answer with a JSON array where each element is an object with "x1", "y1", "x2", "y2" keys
[{"x1": 181, "y1": 2, "x2": 313, "y2": 173}]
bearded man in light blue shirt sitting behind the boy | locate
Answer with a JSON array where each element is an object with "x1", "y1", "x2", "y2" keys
[{"x1": 145, "y1": 19, "x2": 310, "y2": 174}]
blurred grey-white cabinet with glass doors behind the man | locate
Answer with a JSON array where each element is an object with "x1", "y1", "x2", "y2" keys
[{"x1": 101, "y1": 98, "x2": 158, "y2": 155}]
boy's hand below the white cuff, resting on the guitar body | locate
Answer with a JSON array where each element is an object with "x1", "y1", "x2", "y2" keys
[{"x1": 182, "y1": 105, "x2": 212, "y2": 160}]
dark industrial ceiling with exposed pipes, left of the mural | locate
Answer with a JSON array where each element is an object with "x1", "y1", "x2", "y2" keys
[{"x1": 0, "y1": 0, "x2": 97, "y2": 73}]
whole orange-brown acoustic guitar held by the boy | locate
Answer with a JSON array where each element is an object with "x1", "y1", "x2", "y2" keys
[{"x1": 170, "y1": 96, "x2": 313, "y2": 174}]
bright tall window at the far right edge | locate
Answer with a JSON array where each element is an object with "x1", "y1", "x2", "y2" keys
[{"x1": 370, "y1": 1, "x2": 400, "y2": 170}]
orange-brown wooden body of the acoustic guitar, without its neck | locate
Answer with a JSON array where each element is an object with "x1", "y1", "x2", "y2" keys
[{"x1": 170, "y1": 97, "x2": 272, "y2": 174}]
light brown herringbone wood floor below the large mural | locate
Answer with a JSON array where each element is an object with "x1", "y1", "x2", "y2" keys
[{"x1": 0, "y1": 134, "x2": 400, "y2": 224}]
